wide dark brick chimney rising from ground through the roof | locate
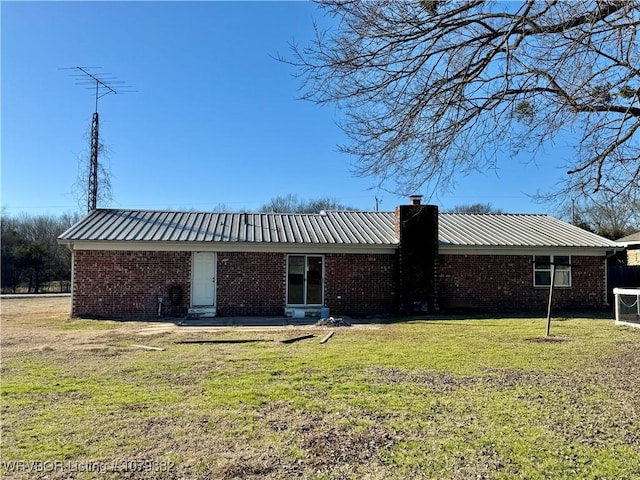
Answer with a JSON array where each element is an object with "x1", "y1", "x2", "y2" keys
[{"x1": 395, "y1": 195, "x2": 439, "y2": 313}]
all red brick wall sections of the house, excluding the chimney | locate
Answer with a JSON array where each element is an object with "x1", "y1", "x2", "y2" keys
[{"x1": 72, "y1": 250, "x2": 605, "y2": 318}]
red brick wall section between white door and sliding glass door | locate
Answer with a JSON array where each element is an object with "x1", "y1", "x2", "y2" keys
[{"x1": 216, "y1": 252, "x2": 287, "y2": 316}]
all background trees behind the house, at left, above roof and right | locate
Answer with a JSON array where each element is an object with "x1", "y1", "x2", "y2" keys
[{"x1": 0, "y1": 194, "x2": 640, "y2": 293}]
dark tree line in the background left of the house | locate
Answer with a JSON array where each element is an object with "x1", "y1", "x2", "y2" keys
[{"x1": 0, "y1": 214, "x2": 81, "y2": 293}]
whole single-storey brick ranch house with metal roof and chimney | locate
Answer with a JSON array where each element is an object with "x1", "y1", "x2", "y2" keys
[{"x1": 59, "y1": 196, "x2": 619, "y2": 318}]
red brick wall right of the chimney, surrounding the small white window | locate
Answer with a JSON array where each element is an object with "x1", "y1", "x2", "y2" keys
[{"x1": 440, "y1": 254, "x2": 606, "y2": 313}]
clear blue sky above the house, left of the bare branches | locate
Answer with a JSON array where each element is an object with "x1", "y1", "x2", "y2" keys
[{"x1": 0, "y1": 1, "x2": 562, "y2": 214}]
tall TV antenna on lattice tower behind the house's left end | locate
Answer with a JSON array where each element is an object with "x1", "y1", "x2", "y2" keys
[{"x1": 60, "y1": 67, "x2": 134, "y2": 212}]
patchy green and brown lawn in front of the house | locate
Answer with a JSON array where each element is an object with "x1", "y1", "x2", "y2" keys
[{"x1": 2, "y1": 310, "x2": 640, "y2": 480}]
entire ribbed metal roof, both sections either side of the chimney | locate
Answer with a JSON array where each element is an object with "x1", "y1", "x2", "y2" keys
[{"x1": 59, "y1": 209, "x2": 619, "y2": 249}]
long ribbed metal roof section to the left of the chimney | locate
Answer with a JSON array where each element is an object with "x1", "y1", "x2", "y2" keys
[{"x1": 59, "y1": 209, "x2": 397, "y2": 245}]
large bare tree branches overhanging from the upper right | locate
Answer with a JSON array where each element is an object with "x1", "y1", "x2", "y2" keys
[{"x1": 288, "y1": 0, "x2": 640, "y2": 199}]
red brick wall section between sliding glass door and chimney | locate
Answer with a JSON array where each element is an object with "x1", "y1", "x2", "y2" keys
[{"x1": 324, "y1": 254, "x2": 397, "y2": 316}]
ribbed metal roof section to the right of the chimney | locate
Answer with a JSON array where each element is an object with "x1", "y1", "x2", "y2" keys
[{"x1": 438, "y1": 213, "x2": 617, "y2": 248}]
